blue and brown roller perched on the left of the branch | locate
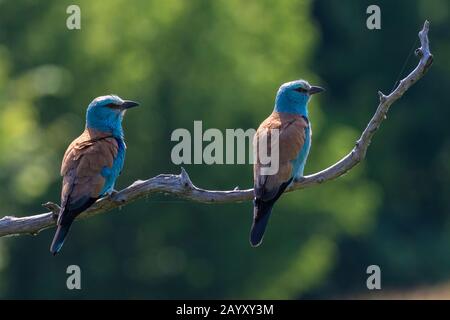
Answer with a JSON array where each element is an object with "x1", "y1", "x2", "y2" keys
[{"x1": 50, "y1": 95, "x2": 139, "y2": 255}]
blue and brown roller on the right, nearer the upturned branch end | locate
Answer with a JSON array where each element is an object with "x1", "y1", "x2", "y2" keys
[{"x1": 250, "y1": 80, "x2": 324, "y2": 246}]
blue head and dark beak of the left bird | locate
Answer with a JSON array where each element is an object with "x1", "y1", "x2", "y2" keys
[{"x1": 86, "y1": 95, "x2": 139, "y2": 137}]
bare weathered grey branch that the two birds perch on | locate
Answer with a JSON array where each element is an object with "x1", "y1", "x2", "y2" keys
[{"x1": 0, "y1": 21, "x2": 433, "y2": 237}]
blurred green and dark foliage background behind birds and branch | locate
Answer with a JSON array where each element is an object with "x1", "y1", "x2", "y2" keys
[{"x1": 0, "y1": 0, "x2": 450, "y2": 299}]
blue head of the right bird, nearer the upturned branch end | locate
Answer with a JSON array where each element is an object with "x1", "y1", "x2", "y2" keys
[{"x1": 275, "y1": 80, "x2": 325, "y2": 116}]
